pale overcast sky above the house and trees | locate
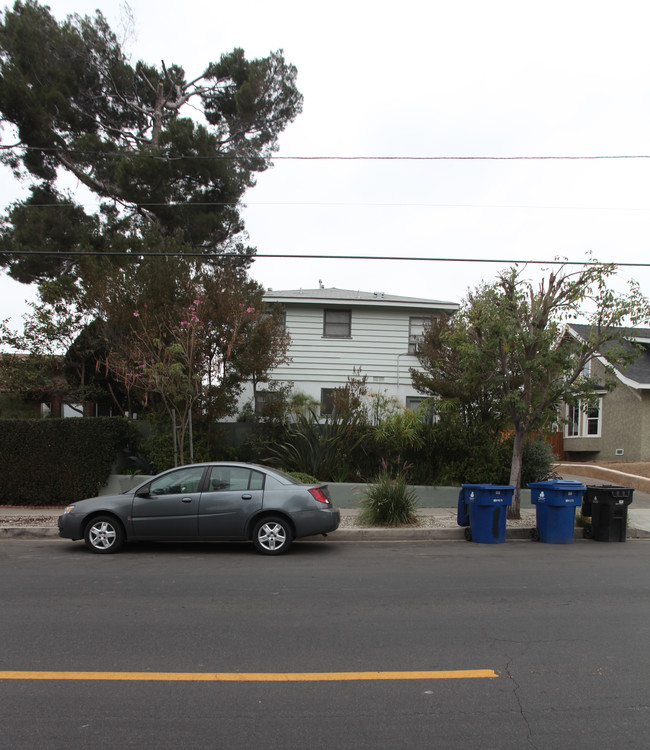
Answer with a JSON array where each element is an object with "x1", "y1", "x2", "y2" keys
[{"x1": 0, "y1": 0, "x2": 650, "y2": 332}]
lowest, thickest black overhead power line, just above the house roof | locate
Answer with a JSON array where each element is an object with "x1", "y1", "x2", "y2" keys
[{"x1": 4, "y1": 250, "x2": 650, "y2": 268}]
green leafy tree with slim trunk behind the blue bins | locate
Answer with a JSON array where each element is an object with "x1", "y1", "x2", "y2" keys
[{"x1": 412, "y1": 263, "x2": 650, "y2": 517}]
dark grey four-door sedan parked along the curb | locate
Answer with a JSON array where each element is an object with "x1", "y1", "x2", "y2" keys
[{"x1": 58, "y1": 462, "x2": 340, "y2": 555}]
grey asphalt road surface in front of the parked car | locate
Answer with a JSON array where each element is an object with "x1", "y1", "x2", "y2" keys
[{"x1": 0, "y1": 540, "x2": 650, "y2": 750}]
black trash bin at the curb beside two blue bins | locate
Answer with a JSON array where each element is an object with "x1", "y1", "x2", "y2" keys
[{"x1": 582, "y1": 484, "x2": 634, "y2": 542}]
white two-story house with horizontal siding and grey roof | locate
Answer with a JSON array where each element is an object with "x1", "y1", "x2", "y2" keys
[{"x1": 240, "y1": 288, "x2": 458, "y2": 415}]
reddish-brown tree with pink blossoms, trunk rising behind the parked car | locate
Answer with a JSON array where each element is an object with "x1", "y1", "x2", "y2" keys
[{"x1": 92, "y1": 257, "x2": 288, "y2": 460}]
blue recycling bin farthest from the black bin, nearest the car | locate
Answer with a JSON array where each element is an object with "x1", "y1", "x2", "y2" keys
[{"x1": 462, "y1": 484, "x2": 515, "y2": 544}]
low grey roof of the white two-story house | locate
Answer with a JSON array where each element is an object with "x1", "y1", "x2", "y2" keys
[{"x1": 264, "y1": 287, "x2": 459, "y2": 312}]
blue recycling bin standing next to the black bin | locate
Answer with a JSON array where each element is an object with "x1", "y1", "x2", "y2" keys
[{"x1": 528, "y1": 479, "x2": 587, "y2": 544}]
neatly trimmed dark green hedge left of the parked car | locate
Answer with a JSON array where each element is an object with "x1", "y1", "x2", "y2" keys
[{"x1": 0, "y1": 417, "x2": 130, "y2": 506}]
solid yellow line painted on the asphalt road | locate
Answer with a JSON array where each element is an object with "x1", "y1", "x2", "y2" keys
[{"x1": 0, "y1": 669, "x2": 498, "y2": 682}]
